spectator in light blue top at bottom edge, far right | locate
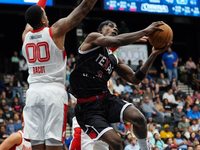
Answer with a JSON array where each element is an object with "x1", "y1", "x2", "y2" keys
[{"x1": 173, "y1": 131, "x2": 188, "y2": 150}]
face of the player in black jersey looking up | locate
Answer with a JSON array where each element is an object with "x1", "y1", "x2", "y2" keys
[{"x1": 102, "y1": 23, "x2": 118, "y2": 36}]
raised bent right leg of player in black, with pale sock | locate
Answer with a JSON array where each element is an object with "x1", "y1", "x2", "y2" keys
[{"x1": 123, "y1": 106, "x2": 148, "y2": 150}]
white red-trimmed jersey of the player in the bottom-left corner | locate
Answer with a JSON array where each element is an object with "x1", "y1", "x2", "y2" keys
[{"x1": 10, "y1": 130, "x2": 32, "y2": 150}]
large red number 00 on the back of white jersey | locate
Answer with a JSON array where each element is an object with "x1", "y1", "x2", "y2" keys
[{"x1": 25, "y1": 42, "x2": 50, "y2": 63}]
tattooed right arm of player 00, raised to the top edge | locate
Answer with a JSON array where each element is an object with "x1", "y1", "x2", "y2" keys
[{"x1": 52, "y1": 0, "x2": 97, "y2": 37}]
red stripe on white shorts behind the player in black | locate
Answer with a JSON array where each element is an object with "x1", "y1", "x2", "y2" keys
[{"x1": 71, "y1": 127, "x2": 81, "y2": 150}]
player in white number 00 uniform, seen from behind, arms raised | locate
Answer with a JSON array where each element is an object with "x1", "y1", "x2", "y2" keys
[{"x1": 22, "y1": 0, "x2": 97, "y2": 150}]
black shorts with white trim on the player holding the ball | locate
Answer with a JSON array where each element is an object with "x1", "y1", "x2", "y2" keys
[{"x1": 75, "y1": 93, "x2": 132, "y2": 140}]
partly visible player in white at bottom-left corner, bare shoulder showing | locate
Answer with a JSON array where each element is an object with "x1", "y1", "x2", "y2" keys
[{"x1": 0, "y1": 122, "x2": 31, "y2": 150}]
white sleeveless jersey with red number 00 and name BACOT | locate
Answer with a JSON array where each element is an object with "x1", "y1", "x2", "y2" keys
[{"x1": 22, "y1": 27, "x2": 67, "y2": 84}]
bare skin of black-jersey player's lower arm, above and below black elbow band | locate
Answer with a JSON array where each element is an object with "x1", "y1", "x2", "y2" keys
[{"x1": 115, "y1": 43, "x2": 171, "y2": 84}]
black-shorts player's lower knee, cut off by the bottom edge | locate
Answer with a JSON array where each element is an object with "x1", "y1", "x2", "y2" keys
[{"x1": 100, "y1": 129, "x2": 123, "y2": 150}]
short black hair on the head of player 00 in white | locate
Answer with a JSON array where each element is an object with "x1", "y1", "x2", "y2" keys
[{"x1": 25, "y1": 5, "x2": 43, "y2": 27}]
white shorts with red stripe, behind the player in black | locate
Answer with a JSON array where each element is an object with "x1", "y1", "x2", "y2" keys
[{"x1": 69, "y1": 117, "x2": 109, "y2": 150}]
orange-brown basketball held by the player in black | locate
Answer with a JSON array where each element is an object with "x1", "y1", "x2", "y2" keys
[{"x1": 148, "y1": 24, "x2": 173, "y2": 48}]
